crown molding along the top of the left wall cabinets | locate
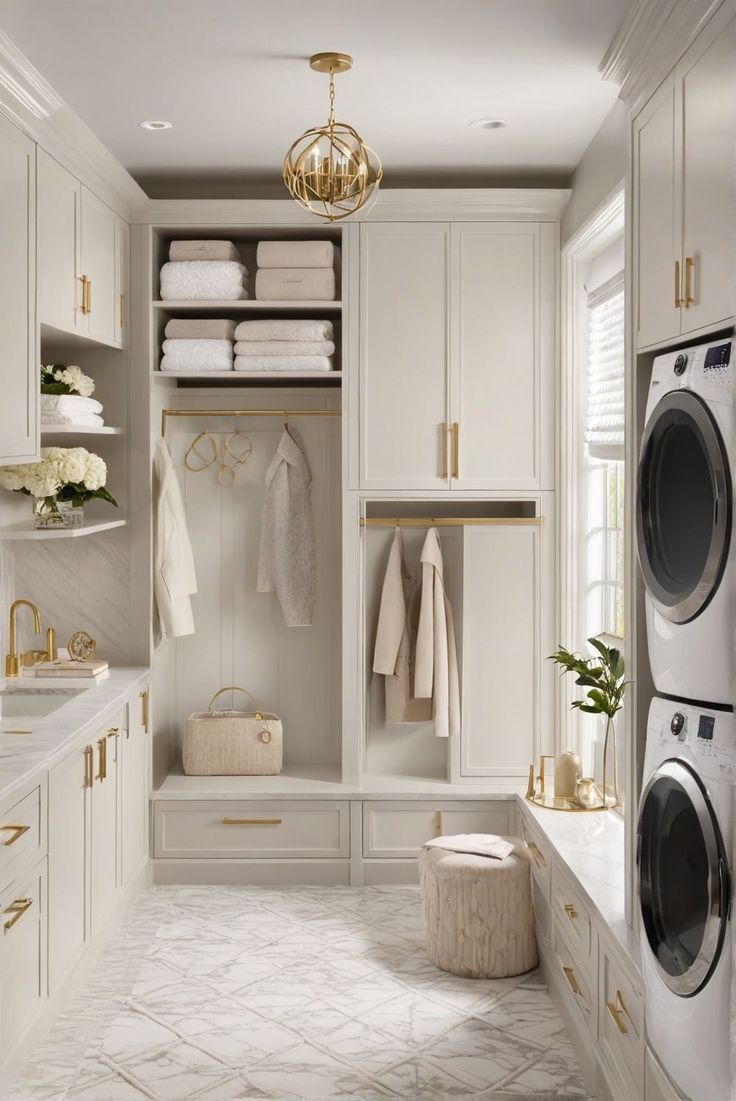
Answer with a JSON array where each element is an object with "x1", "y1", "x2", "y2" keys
[{"x1": 0, "y1": 30, "x2": 149, "y2": 220}]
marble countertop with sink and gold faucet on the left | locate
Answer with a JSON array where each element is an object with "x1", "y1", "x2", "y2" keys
[{"x1": 0, "y1": 667, "x2": 149, "y2": 803}]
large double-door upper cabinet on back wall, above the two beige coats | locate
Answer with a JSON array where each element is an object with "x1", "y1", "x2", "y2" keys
[{"x1": 360, "y1": 222, "x2": 555, "y2": 491}]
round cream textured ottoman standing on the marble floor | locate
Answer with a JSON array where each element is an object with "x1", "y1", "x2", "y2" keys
[{"x1": 419, "y1": 838, "x2": 539, "y2": 979}]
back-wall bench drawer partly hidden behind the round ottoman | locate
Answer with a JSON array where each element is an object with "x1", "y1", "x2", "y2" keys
[{"x1": 362, "y1": 799, "x2": 512, "y2": 860}]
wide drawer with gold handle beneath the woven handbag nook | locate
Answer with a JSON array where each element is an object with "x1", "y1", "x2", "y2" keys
[{"x1": 153, "y1": 800, "x2": 350, "y2": 860}]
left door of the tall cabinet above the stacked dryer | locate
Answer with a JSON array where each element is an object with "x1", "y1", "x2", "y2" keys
[{"x1": 634, "y1": 77, "x2": 681, "y2": 348}]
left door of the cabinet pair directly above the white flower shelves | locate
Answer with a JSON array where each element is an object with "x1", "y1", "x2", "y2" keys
[{"x1": 39, "y1": 150, "x2": 84, "y2": 333}]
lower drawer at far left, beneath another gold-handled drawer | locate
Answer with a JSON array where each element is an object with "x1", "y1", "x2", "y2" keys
[{"x1": 0, "y1": 857, "x2": 46, "y2": 1058}]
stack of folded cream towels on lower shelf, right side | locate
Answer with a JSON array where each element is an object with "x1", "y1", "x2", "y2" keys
[{"x1": 235, "y1": 318, "x2": 335, "y2": 371}]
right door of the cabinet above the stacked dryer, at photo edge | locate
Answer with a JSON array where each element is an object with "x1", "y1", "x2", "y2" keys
[{"x1": 678, "y1": 12, "x2": 736, "y2": 333}]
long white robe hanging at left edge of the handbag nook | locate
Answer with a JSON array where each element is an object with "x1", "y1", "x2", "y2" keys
[{"x1": 153, "y1": 438, "x2": 197, "y2": 639}]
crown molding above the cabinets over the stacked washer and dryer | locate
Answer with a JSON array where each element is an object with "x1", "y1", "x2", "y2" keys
[{"x1": 598, "y1": 0, "x2": 736, "y2": 108}]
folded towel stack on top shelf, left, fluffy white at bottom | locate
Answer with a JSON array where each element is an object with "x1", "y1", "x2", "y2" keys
[{"x1": 161, "y1": 241, "x2": 248, "y2": 302}]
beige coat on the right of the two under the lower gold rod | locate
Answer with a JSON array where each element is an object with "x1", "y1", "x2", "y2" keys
[{"x1": 414, "y1": 527, "x2": 461, "y2": 738}]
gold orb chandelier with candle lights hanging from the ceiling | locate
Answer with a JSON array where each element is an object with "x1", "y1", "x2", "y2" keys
[{"x1": 283, "y1": 53, "x2": 383, "y2": 221}]
